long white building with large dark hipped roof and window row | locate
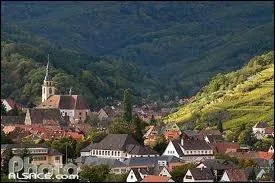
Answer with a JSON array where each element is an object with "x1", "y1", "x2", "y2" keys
[{"x1": 81, "y1": 134, "x2": 159, "y2": 161}]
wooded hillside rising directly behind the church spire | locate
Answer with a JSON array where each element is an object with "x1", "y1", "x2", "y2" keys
[{"x1": 1, "y1": 24, "x2": 160, "y2": 108}]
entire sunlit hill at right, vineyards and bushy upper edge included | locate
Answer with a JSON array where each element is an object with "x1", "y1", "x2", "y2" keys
[{"x1": 165, "y1": 52, "x2": 274, "y2": 131}]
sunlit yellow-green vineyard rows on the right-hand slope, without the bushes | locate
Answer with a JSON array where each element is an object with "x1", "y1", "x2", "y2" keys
[{"x1": 165, "y1": 53, "x2": 274, "y2": 129}]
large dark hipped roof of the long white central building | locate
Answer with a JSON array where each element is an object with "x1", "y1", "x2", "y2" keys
[{"x1": 81, "y1": 134, "x2": 158, "y2": 155}]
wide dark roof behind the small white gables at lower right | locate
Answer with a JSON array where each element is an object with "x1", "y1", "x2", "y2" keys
[{"x1": 199, "y1": 159, "x2": 236, "y2": 170}]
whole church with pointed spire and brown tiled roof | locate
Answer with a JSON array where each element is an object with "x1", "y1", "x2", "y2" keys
[{"x1": 38, "y1": 58, "x2": 90, "y2": 123}]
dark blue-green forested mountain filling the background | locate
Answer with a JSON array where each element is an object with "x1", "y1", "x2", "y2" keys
[{"x1": 1, "y1": 1, "x2": 274, "y2": 97}]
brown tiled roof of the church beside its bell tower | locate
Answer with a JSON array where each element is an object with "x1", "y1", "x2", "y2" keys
[{"x1": 39, "y1": 95, "x2": 89, "y2": 109}]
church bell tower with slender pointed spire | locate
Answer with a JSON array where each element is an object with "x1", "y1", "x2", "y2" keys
[{"x1": 42, "y1": 54, "x2": 55, "y2": 102}]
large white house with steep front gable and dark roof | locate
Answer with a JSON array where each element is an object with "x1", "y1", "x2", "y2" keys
[{"x1": 163, "y1": 139, "x2": 214, "y2": 162}]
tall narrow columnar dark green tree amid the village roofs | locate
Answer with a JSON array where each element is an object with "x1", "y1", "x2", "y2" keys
[{"x1": 123, "y1": 89, "x2": 133, "y2": 122}]
